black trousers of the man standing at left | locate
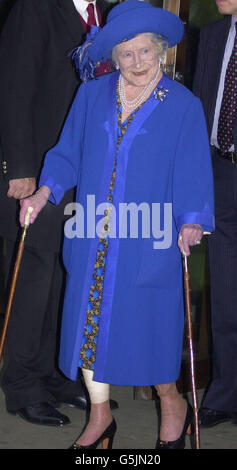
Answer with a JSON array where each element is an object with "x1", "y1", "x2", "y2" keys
[{"x1": 1, "y1": 240, "x2": 84, "y2": 411}]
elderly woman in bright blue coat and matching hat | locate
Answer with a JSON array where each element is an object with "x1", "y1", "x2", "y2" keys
[{"x1": 20, "y1": 0, "x2": 214, "y2": 449}]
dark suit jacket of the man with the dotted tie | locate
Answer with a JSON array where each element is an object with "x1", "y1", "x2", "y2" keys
[{"x1": 193, "y1": 16, "x2": 237, "y2": 148}]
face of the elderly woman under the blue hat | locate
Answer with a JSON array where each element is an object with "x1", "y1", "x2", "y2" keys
[{"x1": 115, "y1": 34, "x2": 159, "y2": 86}]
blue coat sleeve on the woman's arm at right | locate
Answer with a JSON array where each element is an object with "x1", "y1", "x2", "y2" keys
[{"x1": 173, "y1": 97, "x2": 215, "y2": 232}]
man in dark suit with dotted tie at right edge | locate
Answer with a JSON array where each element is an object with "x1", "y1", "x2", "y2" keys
[{"x1": 194, "y1": 0, "x2": 237, "y2": 427}]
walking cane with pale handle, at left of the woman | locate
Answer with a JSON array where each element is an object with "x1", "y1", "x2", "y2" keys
[{"x1": 0, "y1": 207, "x2": 33, "y2": 363}]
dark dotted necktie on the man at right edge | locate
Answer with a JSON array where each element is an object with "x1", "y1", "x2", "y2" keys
[{"x1": 217, "y1": 23, "x2": 237, "y2": 152}]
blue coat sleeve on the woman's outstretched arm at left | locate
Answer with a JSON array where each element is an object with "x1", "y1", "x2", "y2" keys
[{"x1": 39, "y1": 84, "x2": 86, "y2": 204}]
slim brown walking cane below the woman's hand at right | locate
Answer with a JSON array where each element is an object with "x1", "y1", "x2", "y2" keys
[{"x1": 183, "y1": 253, "x2": 200, "y2": 449}]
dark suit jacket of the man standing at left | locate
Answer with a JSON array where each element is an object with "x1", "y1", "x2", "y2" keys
[{"x1": 0, "y1": 0, "x2": 108, "y2": 251}]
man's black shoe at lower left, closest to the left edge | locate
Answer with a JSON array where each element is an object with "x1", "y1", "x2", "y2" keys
[{"x1": 11, "y1": 403, "x2": 70, "y2": 426}]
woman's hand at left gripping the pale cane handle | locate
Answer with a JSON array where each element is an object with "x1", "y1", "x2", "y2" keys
[{"x1": 20, "y1": 186, "x2": 51, "y2": 227}]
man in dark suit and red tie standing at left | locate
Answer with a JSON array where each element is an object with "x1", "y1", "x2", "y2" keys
[{"x1": 0, "y1": 0, "x2": 116, "y2": 426}]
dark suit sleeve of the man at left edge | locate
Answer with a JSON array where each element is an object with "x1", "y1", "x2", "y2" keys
[{"x1": 0, "y1": 0, "x2": 45, "y2": 179}]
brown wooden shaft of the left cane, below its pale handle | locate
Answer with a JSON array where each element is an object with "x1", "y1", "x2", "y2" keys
[{"x1": 0, "y1": 239, "x2": 24, "y2": 362}]
